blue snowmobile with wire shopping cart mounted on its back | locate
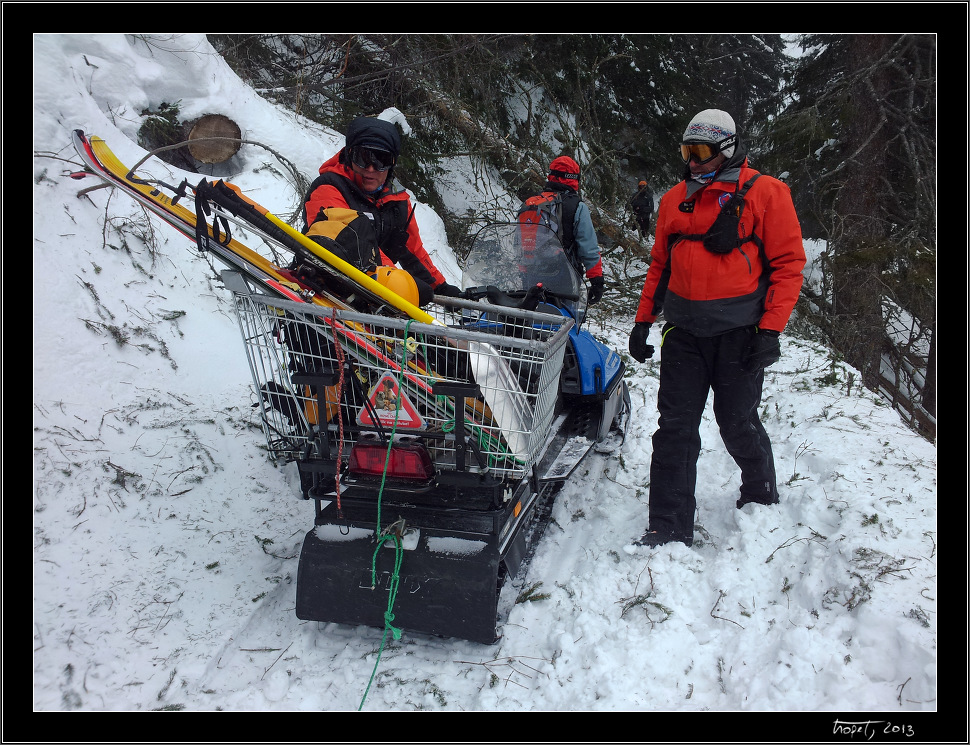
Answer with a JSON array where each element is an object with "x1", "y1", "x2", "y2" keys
[{"x1": 230, "y1": 223, "x2": 630, "y2": 644}]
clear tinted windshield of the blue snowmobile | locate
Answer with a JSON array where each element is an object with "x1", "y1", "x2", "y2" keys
[{"x1": 462, "y1": 223, "x2": 582, "y2": 310}]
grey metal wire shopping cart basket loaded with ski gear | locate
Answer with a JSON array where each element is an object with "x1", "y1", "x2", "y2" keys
[{"x1": 227, "y1": 282, "x2": 574, "y2": 478}]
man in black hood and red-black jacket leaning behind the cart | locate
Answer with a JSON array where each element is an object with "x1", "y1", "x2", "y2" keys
[{"x1": 303, "y1": 117, "x2": 461, "y2": 305}]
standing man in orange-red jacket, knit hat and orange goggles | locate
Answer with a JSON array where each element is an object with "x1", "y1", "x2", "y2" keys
[{"x1": 629, "y1": 109, "x2": 805, "y2": 546}]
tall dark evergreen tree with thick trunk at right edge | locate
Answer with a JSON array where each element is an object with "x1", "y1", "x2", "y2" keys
[{"x1": 769, "y1": 34, "x2": 936, "y2": 430}]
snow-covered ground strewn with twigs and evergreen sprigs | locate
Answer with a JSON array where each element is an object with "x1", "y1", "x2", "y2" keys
[{"x1": 34, "y1": 35, "x2": 940, "y2": 728}]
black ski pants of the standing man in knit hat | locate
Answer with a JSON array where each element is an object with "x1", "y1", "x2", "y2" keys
[{"x1": 650, "y1": 324, "x2": 778, "y2": 543}]
